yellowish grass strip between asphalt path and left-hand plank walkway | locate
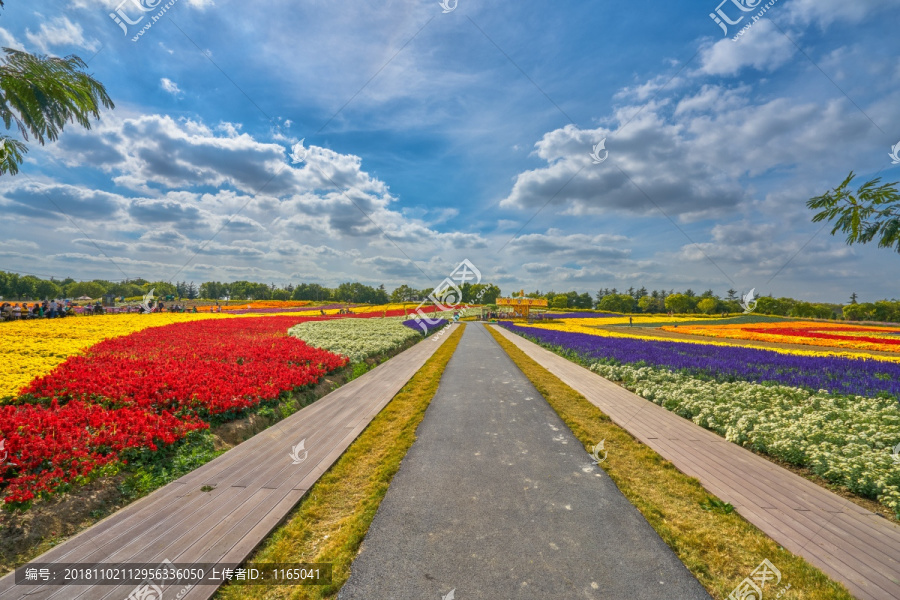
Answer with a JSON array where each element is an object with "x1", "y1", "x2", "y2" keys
[{"x1": 216, "y1": 325, "x2": 465, "y2": 600}]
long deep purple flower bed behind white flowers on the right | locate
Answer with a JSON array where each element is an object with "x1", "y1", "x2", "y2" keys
[{"x1": 500, "y1": 322, "x2": 900, "y2": 398}]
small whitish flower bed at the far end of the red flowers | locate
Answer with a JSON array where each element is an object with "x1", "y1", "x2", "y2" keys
[{"x1": 288, "y1": 318, "x2": 422, "y2": 362}]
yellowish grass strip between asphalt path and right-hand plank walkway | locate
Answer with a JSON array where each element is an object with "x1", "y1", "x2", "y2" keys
[{"x1": 488, "y1": 328, "x2": 853, "y2": 600}]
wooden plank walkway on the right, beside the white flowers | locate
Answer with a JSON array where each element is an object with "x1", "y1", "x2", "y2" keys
[{"x1": 495, "y1": 327, "x2": 900, "y2": 600}]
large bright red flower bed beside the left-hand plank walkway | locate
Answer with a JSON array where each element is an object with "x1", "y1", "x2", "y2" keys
[{"x1": 0, "y1": 315, "x2": 348, "y2": 504}]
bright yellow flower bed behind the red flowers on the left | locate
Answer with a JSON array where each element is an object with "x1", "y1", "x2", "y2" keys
[{"x1": 0, "y1": 313, "x2": 229, "y2": 399}]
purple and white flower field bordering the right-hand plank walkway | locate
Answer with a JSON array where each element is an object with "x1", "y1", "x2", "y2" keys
[{"x1": 501, "y1": 323, "x2": 900, "y2": 516}]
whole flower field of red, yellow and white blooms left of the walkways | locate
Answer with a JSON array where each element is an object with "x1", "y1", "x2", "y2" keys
[{"x1": 0, "y1": 305, "x2": 442, "y2": 506}]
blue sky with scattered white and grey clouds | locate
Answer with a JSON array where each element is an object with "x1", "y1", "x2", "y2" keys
[{"x1": 0, "y1": 0, "x2": 900, "y2": 301}]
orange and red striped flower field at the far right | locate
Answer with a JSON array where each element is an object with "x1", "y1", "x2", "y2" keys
[{"x1": 662, "y1": 321, "x2": 900, "y2": 352}]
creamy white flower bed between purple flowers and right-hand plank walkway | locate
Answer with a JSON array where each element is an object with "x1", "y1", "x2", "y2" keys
[{"x1": 591, "y1": 364, "x2": 900, "y2": 516}]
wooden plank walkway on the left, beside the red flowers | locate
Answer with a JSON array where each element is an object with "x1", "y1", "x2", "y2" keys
[{"x1": 0, "y1": 334, "x2": 460, "y2": 600}]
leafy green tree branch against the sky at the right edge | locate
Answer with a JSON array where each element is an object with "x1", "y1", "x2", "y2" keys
[{"x1": 806, "y1": 171, "x2": 900, "y2": 252}]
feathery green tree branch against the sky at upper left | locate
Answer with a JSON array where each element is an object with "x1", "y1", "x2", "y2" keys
[{"x1": 0, "y1": 48, "x2": 115, "y2": 175}]
